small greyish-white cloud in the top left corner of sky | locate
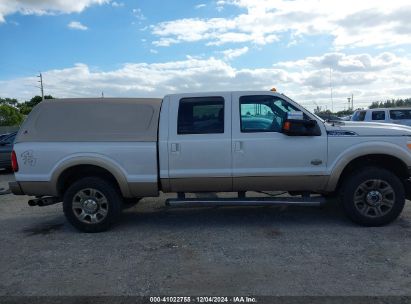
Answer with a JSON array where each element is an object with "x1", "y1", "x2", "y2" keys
[{"x1": 0, "y1": 0, "x2": 109, "y2": 23}]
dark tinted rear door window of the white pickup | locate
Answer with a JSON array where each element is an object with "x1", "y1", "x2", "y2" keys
[{"x1": 177, "y1": 97, "x2": 224, "y2": 134}]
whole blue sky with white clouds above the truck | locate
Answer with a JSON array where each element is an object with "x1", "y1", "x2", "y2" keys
[{"x1": 0, "y1": 0, "x2": 411, "y2": 111}]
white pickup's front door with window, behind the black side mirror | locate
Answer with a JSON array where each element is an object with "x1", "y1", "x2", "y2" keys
[{"x1": 232, "y1": 93, "x2": 327, "y2": 191}]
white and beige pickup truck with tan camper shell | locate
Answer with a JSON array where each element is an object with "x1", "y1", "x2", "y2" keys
[{"x1": 10, "y1": 91, "x2": 411, "y2": 232}]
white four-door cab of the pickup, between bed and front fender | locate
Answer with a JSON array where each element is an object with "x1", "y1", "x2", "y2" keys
[{"x1": 159, "y1": 92, "x2": 327, "y2": 192}]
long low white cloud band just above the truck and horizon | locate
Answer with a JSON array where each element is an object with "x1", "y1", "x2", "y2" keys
[{"x1": 0, "y1": 53, "x2": 411, "y2": 110}]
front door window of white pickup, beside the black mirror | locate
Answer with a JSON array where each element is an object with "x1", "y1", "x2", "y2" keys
[{"x1": 240, "y1": 95, "x2": 299, "y2": 133}]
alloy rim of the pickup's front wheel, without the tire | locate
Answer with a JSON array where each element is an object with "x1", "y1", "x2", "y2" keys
[{"x1": 354, "y1": 179, "x2": 395, "y2": 217}]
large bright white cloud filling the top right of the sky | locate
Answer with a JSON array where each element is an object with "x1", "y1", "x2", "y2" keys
[{"x1": 152, "y1": 0, "x2": 411, "y2": 48}]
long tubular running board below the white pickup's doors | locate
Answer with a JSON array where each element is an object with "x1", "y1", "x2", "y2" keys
[{"x1": 166, "y1": 197, "x2": 326, "y2": 208}]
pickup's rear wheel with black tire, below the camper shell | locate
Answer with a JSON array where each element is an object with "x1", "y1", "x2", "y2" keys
[{"x1": 63, "y1": 177, "x2": 122, "y2": 233}]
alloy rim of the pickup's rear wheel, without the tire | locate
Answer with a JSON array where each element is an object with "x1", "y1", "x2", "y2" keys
[{"x1": 72, "y1": 188, "x2": 108, "y2": 224}]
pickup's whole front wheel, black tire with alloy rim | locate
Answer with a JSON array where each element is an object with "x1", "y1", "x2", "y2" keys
[{"x1": 341, "y1": 167, "x2": 405, "y2": 227}]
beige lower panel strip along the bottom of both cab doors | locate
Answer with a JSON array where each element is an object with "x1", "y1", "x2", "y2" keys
[{"x1": 161, "y1": 175, "x2": 328, "y2": 192}]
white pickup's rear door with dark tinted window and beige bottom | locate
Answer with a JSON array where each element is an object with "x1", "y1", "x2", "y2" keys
[{"x1": 168, "y1": 93, "x2": 232, "y2": 192}]
